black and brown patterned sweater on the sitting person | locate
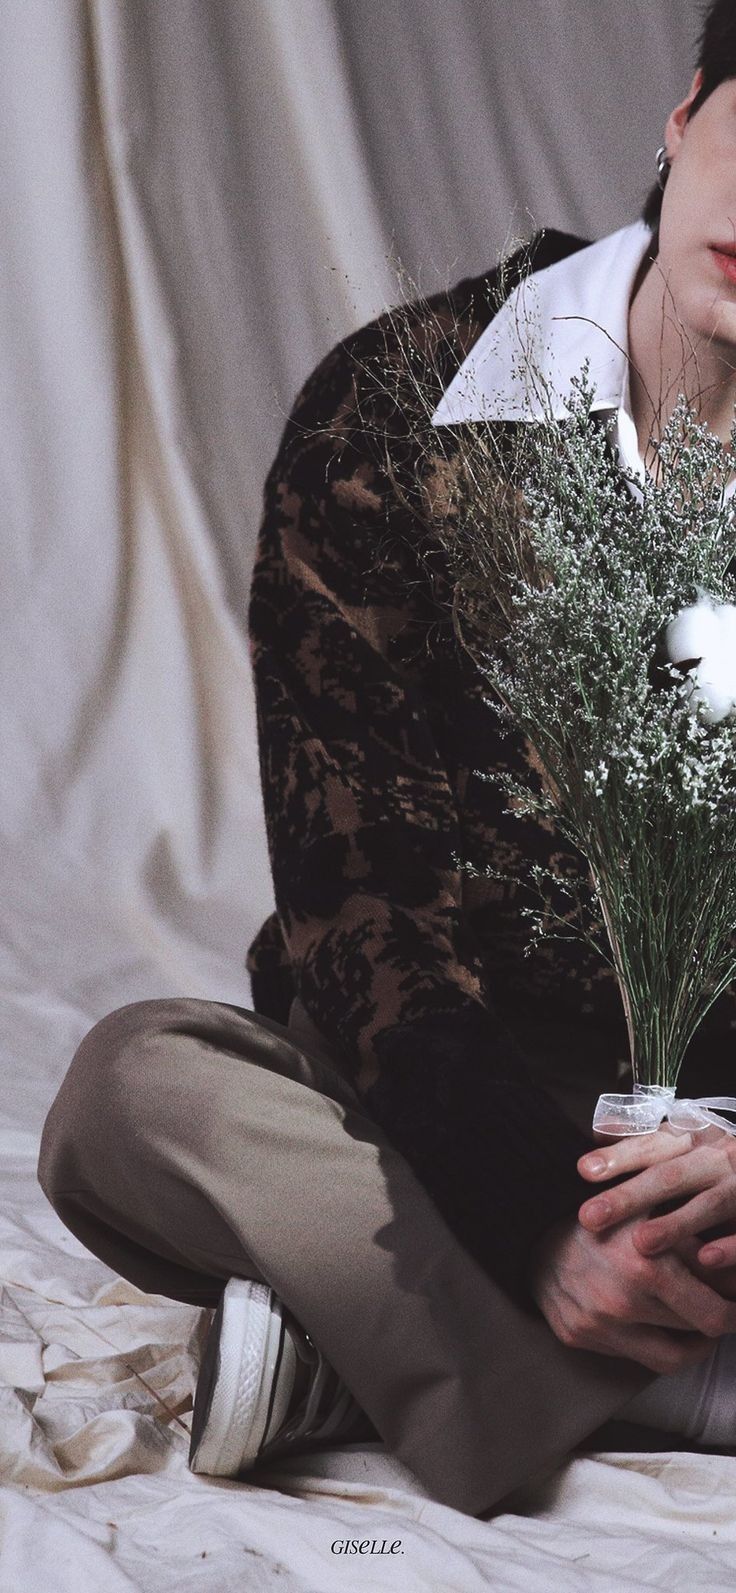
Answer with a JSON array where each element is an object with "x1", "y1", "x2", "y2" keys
[{"x1": 249, "y1": 233, "x2": 733, "y2": 1298}]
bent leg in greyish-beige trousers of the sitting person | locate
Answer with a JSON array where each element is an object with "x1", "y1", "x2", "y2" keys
[{"x1": 38, "y1": 999, "x2": 648, "y2": 1515}]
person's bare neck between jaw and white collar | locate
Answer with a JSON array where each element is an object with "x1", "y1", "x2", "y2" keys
[{"x1": 629, "y1": 260, "x2": 736, "y2": 473}]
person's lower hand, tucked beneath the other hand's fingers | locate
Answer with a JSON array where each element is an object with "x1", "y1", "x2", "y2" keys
[{"x1": 529, "y1": 1217, "x2": 736, "y2": 1373}]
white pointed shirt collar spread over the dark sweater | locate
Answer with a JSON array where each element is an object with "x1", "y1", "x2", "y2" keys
[{"x1": 432, "y1": 221, "x2": 736, "y2": 497}]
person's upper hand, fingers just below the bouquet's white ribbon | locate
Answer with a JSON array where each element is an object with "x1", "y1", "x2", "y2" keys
[{"x1": 578, "y1": 1128, "x2": 736, "y2": 1292}]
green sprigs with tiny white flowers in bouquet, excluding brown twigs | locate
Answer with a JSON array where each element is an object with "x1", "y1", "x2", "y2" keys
[{"x1": 478, "y1": 374, "x2": 736, "y2": 1085}]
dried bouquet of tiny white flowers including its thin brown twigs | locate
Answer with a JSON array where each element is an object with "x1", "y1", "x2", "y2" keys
[{"x1": 347, "y1": 248, "x2": 736, "y2": 1085}]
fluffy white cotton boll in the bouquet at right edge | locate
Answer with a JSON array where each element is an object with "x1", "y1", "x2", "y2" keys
[{"x1": 664, "y1": 586, "x2": 736, "y2": 725}]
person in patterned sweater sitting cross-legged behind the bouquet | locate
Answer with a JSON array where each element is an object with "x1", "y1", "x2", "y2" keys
[{"x1": 38, "y1": 0, "x2": 736, "y2": 1515}]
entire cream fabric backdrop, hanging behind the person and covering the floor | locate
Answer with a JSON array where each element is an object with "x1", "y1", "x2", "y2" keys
[{"x1": 0, "y1": 0, "x2": 733, "y2": 1593}]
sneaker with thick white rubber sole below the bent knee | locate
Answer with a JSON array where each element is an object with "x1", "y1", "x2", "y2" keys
[{"x1": 190, "y1": 1278, "x2": 366, "y2": 1477}]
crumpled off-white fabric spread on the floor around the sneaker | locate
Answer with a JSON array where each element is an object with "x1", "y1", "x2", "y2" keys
[{"x1": 0, "y1": 1129, "x2": 736, "y2": 1593}]
